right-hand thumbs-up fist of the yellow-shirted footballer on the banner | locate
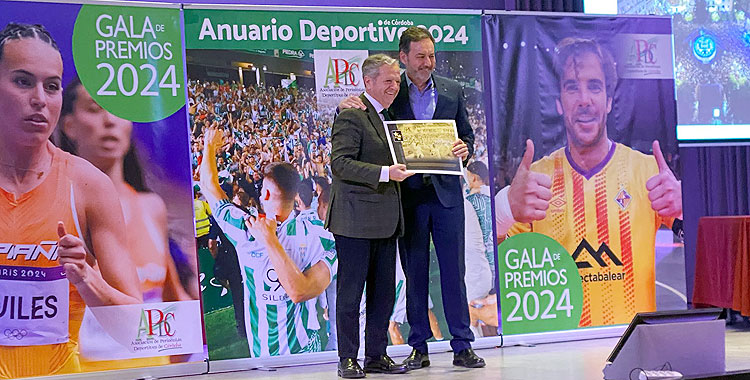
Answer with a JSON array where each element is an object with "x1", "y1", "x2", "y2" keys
[{"x1": 646, "y1": 141, "x2": 682, "y2": 218}]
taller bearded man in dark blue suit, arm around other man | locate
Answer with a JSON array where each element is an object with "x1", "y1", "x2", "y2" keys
[{"x1": 340, "y1": 27, "x2": 485, "y2": 369}]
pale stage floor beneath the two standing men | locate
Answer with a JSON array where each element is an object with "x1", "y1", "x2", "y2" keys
[{"x1": 183, "y1": 322, "x2": 750, "y2": 380}]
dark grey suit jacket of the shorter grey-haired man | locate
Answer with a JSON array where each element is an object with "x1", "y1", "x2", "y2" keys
[{"x1": 326, "y1": 95, "x2": 404, "y2": 239}]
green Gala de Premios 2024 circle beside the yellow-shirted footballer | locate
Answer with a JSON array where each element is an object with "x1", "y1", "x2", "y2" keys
[{"x1": 498, "y1": 232, "x2": 583, "y2": 334}]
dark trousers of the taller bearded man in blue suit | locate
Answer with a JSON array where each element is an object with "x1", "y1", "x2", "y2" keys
[{"x1": 400, "y1": 185, "x2": 474, "y2": 353}]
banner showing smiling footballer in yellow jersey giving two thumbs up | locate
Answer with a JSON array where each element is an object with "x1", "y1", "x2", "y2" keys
[{"x1": 483, "y1": 15, "x2": 681, "y2": 334}]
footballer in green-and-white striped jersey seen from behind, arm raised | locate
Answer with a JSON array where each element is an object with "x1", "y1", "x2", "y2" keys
[{"x1": 200, "y1": 129, "x2": 337, "y2": 357}]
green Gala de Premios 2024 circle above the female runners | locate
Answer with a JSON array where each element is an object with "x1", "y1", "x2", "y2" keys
[{"x1": 73, "y1": 5, "x2": 185, "y2": 122}]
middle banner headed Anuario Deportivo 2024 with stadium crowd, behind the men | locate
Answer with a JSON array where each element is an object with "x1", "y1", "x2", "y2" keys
[{"x1": 185, "y1": 8, "x2": 497, "y2": 360}]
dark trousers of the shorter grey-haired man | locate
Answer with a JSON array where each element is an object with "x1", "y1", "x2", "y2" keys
[{"x1": 334, "y1": 235, "x2": 396, "y2": 358}]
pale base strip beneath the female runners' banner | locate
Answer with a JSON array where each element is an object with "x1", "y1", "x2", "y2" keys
[{"x1": 24, "y1": 361, "x2": 208, "y2": 380}]
